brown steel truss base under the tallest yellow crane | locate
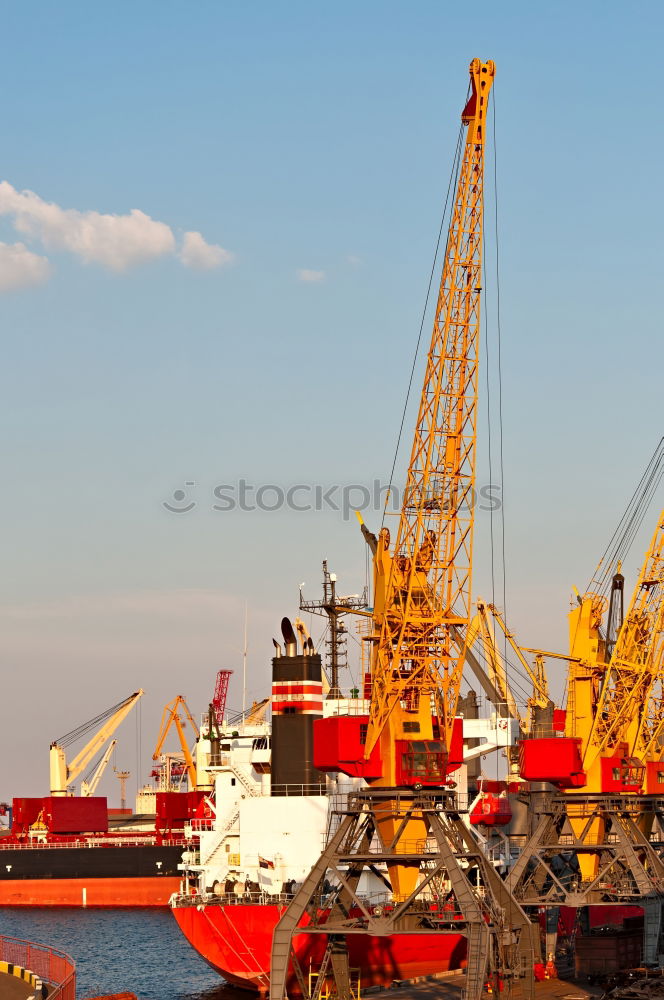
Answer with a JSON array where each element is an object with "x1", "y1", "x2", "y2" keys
[{"x1": 270, "y1": 788, "x2": 539, "y2": 1000}]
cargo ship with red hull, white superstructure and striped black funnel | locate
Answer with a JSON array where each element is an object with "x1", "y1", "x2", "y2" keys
[{"x1": 170, "y1": 598, "x2": 514, "y2": 994}]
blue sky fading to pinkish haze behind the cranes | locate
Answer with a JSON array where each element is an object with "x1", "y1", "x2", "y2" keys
[{"x1": 0, "y1": 0, "x2": 664, "y2": 798}]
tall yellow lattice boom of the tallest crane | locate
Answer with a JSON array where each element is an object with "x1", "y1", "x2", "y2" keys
[{"x1": 365, "y1": 59, "x2": 494, "y2": 758}]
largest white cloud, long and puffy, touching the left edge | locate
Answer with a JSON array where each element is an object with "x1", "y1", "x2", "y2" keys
[{"x1": 0, "y1": 181, "x2": 175, "y2": 271}]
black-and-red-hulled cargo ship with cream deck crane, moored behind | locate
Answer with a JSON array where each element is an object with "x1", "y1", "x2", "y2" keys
[{"x1": 0, "y1": 691, "x2": 235, "y2": 907}]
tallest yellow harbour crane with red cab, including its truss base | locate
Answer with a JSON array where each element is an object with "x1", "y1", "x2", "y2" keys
[{"x1": 270, "y1": 59, "x2": 535, "y2": 1000}]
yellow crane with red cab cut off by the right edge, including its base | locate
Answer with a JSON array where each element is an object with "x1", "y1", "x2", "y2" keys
[{"x1": 506, "y1": 511, "x2": 664, "y2": 948}]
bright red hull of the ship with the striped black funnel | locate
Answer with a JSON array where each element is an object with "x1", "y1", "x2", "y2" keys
[{"x1": 173, "y1": 903, "x2": 466, "y2": 994}]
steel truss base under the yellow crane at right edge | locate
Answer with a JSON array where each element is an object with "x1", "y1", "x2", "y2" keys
[{"x1": 505, "y1": 793, "x2": 664, "y2": 964}]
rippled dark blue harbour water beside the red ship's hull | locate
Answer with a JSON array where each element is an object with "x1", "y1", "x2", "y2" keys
[{"x1": 0, "y1": 907, "x2": 239, "y2": 1000}]
